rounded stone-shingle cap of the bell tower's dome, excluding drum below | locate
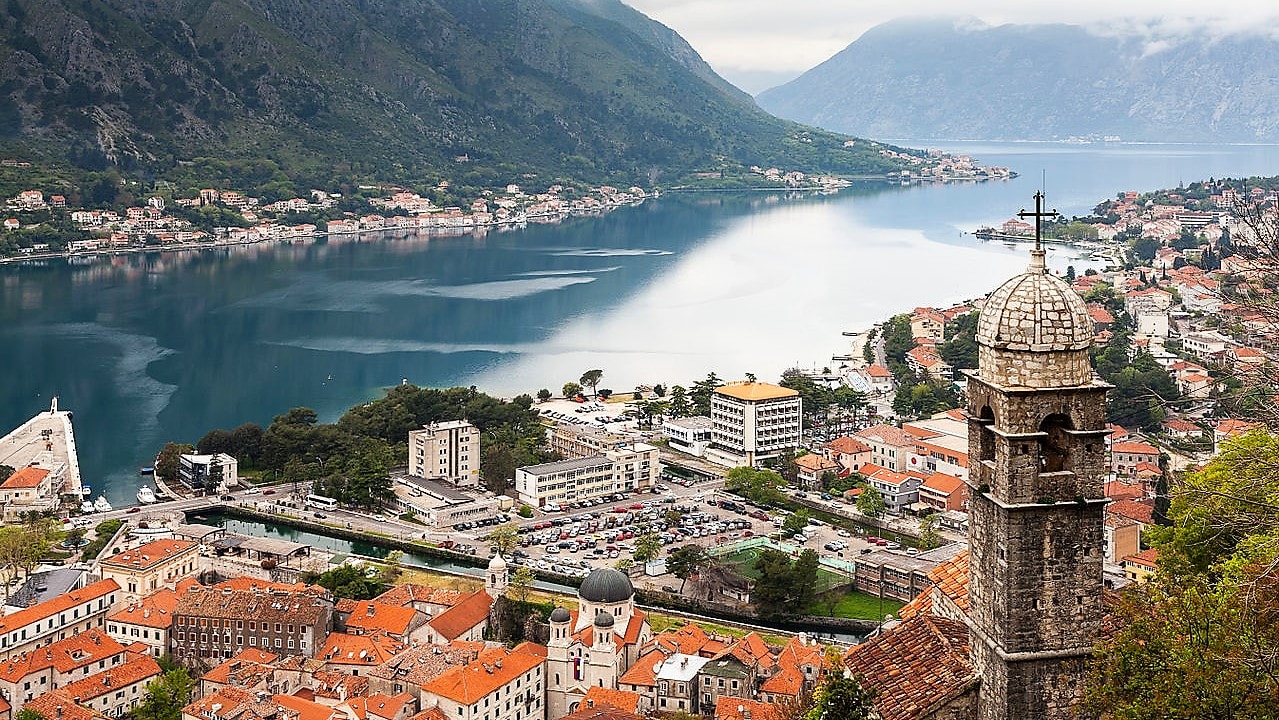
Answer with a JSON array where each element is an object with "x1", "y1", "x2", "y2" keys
[{"x1": 977, "y1": 251, "x2": 1092, "y2": 353}]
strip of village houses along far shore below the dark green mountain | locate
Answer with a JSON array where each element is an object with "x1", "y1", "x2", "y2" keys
[{"x1": 0, "y1": 150, "x2": 1013, "y2": 261}]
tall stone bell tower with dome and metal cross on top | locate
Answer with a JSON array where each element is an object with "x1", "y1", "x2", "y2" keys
[{"x1": 966, "y1": 193, "x2": 1109, "y2": 720}]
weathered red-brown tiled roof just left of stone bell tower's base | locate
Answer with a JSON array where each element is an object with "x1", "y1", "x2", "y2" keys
[{"x1": 844, "y1": 615, "x2": 977, "y2": 720}]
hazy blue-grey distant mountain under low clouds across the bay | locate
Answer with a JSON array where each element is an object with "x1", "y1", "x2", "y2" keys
[{"x1": 757, "y1": 19, "x2": 1279, "y2": 142}]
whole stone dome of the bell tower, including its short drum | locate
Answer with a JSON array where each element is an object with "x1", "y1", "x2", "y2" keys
[{"x1": 977, "y1": 248, "x2": 1092, "y2": 387}]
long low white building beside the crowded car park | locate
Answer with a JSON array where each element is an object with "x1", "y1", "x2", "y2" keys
[{"x1": 515, "y1": 442, "x2": 661, "y2": 508}]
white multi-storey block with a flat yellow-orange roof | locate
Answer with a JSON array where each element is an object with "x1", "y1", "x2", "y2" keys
[{"x1": 706, "y1": 382, "x2": 803, "y2": 467}]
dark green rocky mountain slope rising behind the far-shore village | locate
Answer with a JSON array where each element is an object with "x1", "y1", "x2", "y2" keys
[{"x1": 0, "y1": 0, "x2": 915, "y2": 185}]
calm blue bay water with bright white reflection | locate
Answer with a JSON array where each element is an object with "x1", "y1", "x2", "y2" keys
[{"x1": 0, "y1": 143, "x2": 1279, "y2": 504}]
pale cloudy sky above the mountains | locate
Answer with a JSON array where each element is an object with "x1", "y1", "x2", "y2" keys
[{"x1": 623, "y1": 0, "x2": 1279, "y2": 93}]
